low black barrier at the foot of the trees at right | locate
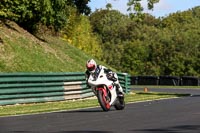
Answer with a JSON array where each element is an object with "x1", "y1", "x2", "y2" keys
[{"x1": 131, "y1": 76, "x2": 200, "y2": 86}]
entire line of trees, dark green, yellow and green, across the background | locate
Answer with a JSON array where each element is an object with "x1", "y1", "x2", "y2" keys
[{"x1": 0, "y1": 0, "x2": 200, "y2": 76}]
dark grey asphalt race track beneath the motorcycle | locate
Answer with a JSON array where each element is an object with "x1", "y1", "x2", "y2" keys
[{"x1": 0, "y1": 89, "x2": 200, "y2": 133}]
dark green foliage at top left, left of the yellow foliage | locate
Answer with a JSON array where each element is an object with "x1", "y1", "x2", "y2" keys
[{"x1": 0, "y1": 0, "x2": 90, "y2": 33}]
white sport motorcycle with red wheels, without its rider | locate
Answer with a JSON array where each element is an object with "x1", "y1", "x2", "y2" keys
[{"x1": 88, "y1": 68, "x2": 125, "y2": 111}]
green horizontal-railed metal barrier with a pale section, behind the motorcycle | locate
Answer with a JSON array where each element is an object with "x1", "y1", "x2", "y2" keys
[{"x1": 0, "y1": 72, "x2": 130, "y2": 105}]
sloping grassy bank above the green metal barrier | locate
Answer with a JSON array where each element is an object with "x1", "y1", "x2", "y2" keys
[{"x1": 0, "y1": 21, "x2": 96, "y2": 72}]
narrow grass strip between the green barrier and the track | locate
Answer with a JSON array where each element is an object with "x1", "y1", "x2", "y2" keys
[{"x1": 0, "y1": 92, "x2": 189, "y2": 116}]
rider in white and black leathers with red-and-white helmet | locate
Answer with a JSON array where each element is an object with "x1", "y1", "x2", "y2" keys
[{"x1": 85, "y1": 59, "x2": 124, "y2": 97}]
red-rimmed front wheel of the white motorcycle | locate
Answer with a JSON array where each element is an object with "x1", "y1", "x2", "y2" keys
[{"x1": 97, "y1": 89, "x2": 110, "y2": 111}]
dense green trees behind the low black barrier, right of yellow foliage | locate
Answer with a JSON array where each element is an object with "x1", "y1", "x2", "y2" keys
[{"x1": 90, "y1": 7, "x2": 200, "y2": 76}]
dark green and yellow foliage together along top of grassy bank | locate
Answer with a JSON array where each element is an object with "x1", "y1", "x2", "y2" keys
[{"x1": 0, "y1": 0, "x2": 102, "y2": 67}]
